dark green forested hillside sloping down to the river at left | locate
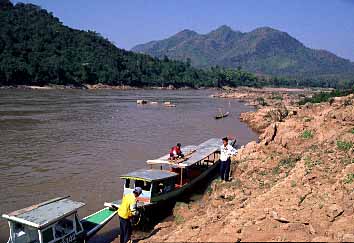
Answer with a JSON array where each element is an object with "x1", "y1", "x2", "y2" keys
[{"x1": 0, "y1": 0, "x2": 221, "y2": 86}]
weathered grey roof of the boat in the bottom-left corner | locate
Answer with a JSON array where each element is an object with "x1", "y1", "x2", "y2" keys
[{"x1": 2, "y1": 197, "x2": 85, "y2": 228}]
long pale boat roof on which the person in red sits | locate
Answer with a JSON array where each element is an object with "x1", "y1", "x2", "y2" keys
[{"x1": 146, "y1": 138, "x2": 227, "y2": 168}]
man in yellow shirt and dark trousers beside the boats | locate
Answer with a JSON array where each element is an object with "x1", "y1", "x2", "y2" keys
[{"x1": 118, "y1": 187, "x2": 142, "y2": 243}]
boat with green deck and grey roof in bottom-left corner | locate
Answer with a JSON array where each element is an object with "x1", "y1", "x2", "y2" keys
[{"x1": 2, "y1": 197, "x2": 116, "y2": 243}]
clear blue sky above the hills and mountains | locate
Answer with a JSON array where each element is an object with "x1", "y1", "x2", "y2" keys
[{"x1": 13, "y1": 0, "x2": 354, "y2": 61}]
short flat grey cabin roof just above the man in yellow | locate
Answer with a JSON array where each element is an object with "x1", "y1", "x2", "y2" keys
[{"x1": 120, "y1": 169, "x2": 177, "y2": 181}]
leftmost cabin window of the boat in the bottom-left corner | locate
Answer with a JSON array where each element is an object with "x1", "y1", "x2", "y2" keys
[{"x1": 12, "y1": 223, "x2": 39, "y2": 243}]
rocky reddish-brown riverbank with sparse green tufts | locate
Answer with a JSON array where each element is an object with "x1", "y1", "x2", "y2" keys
[{"x1": 139, "y1": 89, "x2": 354, "y2": 242}]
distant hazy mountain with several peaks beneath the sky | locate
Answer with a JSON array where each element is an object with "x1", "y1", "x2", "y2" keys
[{"x1": 132, "y1": 25, "x2": 354, "y2": 79}]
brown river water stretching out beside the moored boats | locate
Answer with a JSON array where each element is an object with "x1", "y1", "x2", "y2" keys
[{"x1": 0, "y1": 90, "x2": 257, "y2": 242}]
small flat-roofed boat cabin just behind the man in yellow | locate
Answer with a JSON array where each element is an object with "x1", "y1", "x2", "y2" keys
[{"x1": 121, "y1": 169, "x2": 177, "y2": 204}]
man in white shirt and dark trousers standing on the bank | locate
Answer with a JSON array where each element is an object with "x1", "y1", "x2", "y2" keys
[{"x1": 220, "y1": 137, "x2": 237, "y2": 181}]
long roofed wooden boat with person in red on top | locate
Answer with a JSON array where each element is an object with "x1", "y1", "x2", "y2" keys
[{"x1": 104, "y1": 138, "x2": 233, "y2": 223}]
